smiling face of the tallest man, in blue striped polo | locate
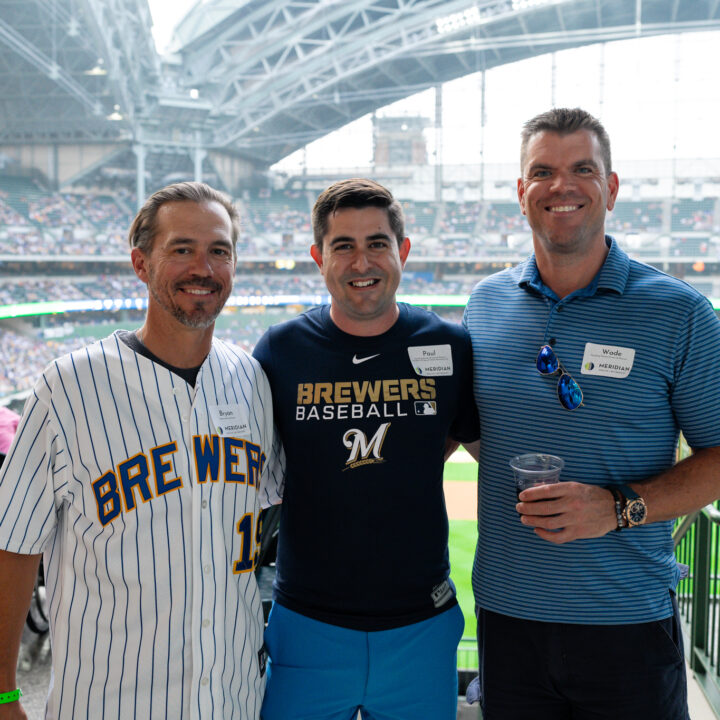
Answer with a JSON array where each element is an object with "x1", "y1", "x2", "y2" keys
[{"x1": 518, "y1": 130, "x2": 618, "y2": 257}]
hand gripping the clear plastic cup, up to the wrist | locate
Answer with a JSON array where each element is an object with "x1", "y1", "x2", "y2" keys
[{"x1": 515, "y1": 482, "x2": 617, "y2": 544}]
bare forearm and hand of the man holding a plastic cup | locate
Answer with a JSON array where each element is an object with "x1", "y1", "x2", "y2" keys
[{"x1": 517, "y1": 447, "x2": 720, "y2": 543}]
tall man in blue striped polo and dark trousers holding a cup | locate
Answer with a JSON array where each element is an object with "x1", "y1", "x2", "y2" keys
[{"x1": 464, "y1": 109, "x2": 720, "y2": 720}]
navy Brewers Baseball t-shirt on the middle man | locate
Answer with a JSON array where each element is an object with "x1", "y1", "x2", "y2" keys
[{"x1": 254, "y1": 303, "x2": 479, "y2": 631}]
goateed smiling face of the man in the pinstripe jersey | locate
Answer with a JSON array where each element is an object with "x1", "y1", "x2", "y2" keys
[{"x1": 131, "y1": 201, "x2": 235, "y2": 329}]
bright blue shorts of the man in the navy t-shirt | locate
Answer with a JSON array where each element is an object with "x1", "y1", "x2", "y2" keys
[{"x1": 260, "y1": 603, "x2": 465, "y2": 720}]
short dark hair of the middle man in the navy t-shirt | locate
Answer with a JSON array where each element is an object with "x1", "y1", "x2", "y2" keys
[{"x1": 312, "y1": 178, "x2": 405, "y2": 251}]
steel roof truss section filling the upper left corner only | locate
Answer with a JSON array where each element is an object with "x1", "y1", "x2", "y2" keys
[{"x1": 0, "y1": 0, "x2": 161, "y2": 143}]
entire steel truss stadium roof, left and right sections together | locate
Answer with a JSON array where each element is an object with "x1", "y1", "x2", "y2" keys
[{"x1": 0, "y1": 0, "x2": 720, "y2": 166}]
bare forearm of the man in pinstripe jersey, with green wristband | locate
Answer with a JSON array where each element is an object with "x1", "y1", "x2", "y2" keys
[{"x1": 0, "y1": 550, "x2": 42, "y2": 720}]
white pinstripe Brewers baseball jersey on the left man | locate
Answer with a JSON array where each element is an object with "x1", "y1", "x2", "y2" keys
[{"x1": 0, "y1": 333, "x2": 284, "y2": 720}]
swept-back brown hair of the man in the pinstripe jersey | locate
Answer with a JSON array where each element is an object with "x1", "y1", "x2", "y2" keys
[{"x1": 128, "y1": 182, "x2": 240, "y2": 253}]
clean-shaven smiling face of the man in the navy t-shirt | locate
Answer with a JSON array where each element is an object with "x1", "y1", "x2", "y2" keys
[{"x1": 310, "y1": 207, "x2": 410, "y2": 336}]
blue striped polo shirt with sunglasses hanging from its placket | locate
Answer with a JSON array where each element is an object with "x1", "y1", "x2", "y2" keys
[{"x1": 464, "y1": 237, "x2": 720, "y2": 624}]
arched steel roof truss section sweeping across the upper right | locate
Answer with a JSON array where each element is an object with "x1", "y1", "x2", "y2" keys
[{"x1": 163, "y1": 0, "x2": 720, "y2": 159}]
